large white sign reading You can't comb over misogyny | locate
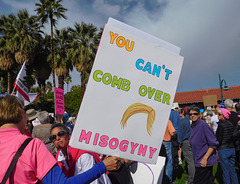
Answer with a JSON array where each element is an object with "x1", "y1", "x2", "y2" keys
[{"x1": 70, "y1": 17, "x2": 183, "y2": 163}]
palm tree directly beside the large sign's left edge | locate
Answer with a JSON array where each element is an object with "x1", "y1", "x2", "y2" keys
[{"x1": 69, "y1": 22, "x2": 99, "y2": 98}]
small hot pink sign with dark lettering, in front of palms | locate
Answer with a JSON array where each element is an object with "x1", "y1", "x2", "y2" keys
[{"x1": 54, "y1": 87, "x2": 64, "y2": 115}]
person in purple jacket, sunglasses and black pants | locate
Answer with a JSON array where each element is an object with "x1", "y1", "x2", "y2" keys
[{"x1": 188, "y1": 106, "x2": 219, "y2": 184}]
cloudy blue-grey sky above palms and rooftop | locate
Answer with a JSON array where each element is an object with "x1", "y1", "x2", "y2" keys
[{"x1": 0, "y1": 0, "x2": 240, "y2": 92}]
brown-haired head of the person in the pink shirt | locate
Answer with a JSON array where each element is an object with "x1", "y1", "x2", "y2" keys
[{"x1": 0, "y1": 95, "x2": 27, "y2": 133}]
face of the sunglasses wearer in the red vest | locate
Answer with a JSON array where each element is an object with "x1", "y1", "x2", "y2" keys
[{"x1": 51, "y1": 127, "x2": 70, "y2": 149}]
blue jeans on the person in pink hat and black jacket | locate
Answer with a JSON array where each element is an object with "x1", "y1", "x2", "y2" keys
[{"x1": 218, "y1": 148, "x2": 239, "y2": 184}]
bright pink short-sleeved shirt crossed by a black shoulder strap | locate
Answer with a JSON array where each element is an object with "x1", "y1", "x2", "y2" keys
[{"x1": 0, "y1": 128, "x2": 57, "y2": 184}]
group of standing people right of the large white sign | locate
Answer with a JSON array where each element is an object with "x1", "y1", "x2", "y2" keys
[{"x1": 163, "y1": 99, "x2": 240, "y2": 184}]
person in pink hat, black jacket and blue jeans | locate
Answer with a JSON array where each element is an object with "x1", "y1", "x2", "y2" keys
[{"x1": 216, "y1": 108, "x2": 239, "y2": 184}]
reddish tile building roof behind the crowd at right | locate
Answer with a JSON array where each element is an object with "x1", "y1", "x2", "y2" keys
[{"x1": 174, "y1": 86, "x2": 240, "y2": 104}]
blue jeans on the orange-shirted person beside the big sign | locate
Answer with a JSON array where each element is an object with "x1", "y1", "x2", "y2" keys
[{"x1": 163, "y1": 141, "x2": 173, "y2": 182}]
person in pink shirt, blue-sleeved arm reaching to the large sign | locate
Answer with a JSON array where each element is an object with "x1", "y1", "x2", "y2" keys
[{"x1": 0, "y1": 95, "x2": 119, "y2": 184}]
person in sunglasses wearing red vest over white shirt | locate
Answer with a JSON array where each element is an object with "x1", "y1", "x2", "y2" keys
[{"x1": 49, "y1": 123, "x2": 111, "y2": 184}]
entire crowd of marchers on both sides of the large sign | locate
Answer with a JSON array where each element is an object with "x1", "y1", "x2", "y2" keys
[{"x1": 0, "y1": 95, "x2": 240, "y2": 184}]
